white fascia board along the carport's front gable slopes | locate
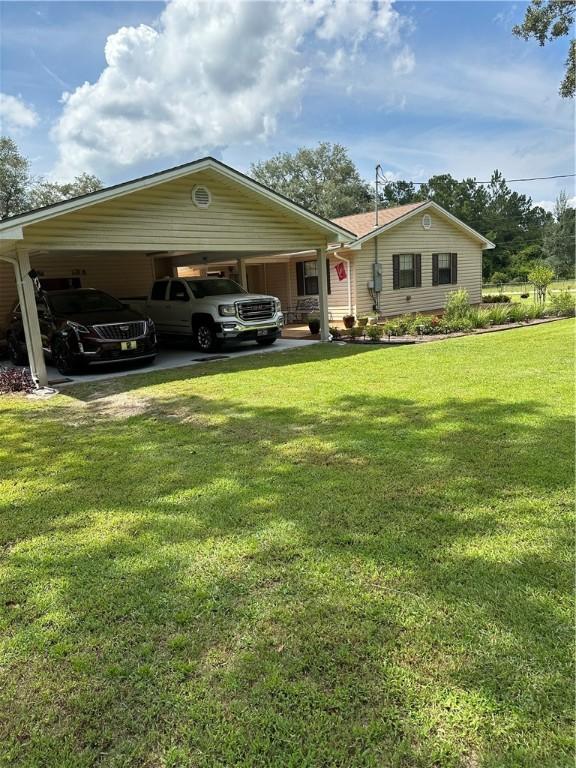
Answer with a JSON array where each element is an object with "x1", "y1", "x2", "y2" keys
[{"x1": 0, "y1": 158, "x2": 354, "y2": 242}]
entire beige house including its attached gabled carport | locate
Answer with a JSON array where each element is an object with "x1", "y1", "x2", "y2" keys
[{"x1": 0, "y1": 157, "x2": 493, "y2": 383}]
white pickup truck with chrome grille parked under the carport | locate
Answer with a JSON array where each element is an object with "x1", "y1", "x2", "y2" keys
[{"x1": 121, "y1": 277, "x2": 284, "y2": 352}]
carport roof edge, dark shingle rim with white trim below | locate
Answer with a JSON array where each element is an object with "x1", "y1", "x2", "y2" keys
[{"x1": 0, "y1": 157, "x2": 355, "y2": 242}]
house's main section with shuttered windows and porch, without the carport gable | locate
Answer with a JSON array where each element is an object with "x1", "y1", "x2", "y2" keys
[{"x1": 184, "y1": 201, "x2": 494, "y2": 321}]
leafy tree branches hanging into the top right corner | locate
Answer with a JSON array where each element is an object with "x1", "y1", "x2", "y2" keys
[{"x1": 512, "y1": 0, "x2": 576, "y2": 98}]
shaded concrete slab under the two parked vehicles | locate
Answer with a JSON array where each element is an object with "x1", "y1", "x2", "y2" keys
[{"x1": 48, "y1": 339, "x2": 317, "y2": 388}]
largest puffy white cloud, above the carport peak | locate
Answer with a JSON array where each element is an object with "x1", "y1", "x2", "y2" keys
[{"x1": 52, "y1": 0, "x2": 410, "y2": 177}]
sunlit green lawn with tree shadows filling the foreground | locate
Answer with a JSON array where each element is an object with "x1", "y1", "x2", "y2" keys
[{"x1": 0, "y1": 320, "x2": 574, "y2": 768}]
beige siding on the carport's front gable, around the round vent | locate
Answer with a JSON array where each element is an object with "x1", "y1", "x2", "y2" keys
[{"x1": 24, "y1": 171, "x2": 326, "y2": 252}]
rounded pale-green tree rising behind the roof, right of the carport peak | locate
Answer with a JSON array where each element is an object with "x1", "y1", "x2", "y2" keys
[{"x1": 250, "y1": 142, "x2": 374, "y2": 219}]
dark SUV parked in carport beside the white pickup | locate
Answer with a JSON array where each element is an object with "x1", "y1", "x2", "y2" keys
[{"x1": 7, "y1": 288, "x2": 157, "y2": 374}]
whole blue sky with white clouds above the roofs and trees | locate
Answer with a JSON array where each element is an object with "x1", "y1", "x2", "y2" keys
[{"x1": 0, "y1": 0, "x2": 574, "y2": 208}]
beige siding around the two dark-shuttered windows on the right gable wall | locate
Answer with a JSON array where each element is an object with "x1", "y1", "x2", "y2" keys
[{"x1": 355, "y1": 211, "x2": 482, "y2": 316}]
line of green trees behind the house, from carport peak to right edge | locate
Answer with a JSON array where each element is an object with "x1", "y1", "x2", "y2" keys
[{"x1": 251, "y1": 142, "x2": 576, "y2": 282}]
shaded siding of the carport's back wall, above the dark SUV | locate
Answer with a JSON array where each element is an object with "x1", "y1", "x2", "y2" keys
[{"x1": 0, "y1": 253, "x2": 154, "y2": 338}]
